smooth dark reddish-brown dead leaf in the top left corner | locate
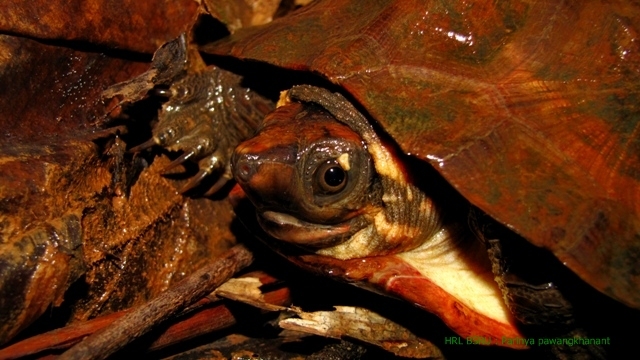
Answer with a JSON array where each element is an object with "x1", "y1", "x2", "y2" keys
[{"x1": 0, "y1": 0, "x2": 198, "y2": 53}]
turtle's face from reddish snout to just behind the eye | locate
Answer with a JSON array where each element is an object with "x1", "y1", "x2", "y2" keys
[{"x1": 233, "y1": 103, "x2": 381, "y2": 248}]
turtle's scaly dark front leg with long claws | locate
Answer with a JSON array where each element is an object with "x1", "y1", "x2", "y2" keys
[{"x1": 137, "y1": 66, "x2": 274, "y2": 194}]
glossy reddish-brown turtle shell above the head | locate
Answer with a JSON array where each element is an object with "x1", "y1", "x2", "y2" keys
[{"x1": 204, "y1": 0, "x2": 640, "y2": 308}]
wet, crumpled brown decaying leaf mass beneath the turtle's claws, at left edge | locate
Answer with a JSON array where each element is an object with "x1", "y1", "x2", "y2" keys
[{"x1": 0, "y1": 27, "x2": 235, "y2": 343}]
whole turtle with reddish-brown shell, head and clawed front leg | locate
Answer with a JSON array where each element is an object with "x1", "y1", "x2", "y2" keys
[{"x1": 119, "y1": 0, "x2": 640, "y2": 356}]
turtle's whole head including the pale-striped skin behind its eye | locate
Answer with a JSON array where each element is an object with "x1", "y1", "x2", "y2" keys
[{"x1": 233, "y1": 87, "x2": 439, "y2": 259}]
